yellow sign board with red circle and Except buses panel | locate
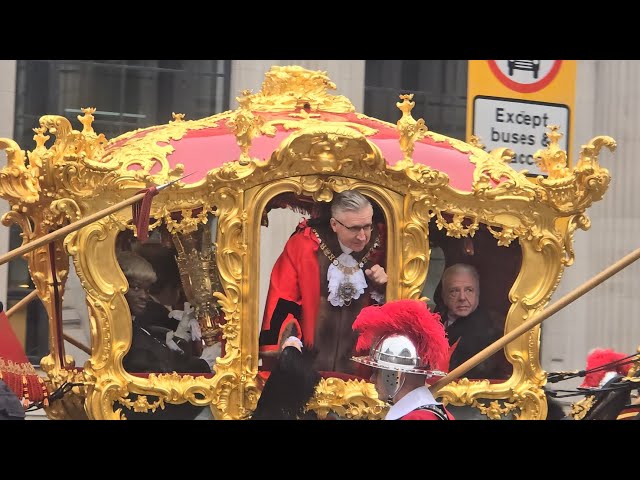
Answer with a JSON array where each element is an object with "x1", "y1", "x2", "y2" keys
[{"x1": 467, "y1": 60, "x2": 576, "y2": 175}]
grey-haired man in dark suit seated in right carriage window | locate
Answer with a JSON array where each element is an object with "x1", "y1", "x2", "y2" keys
[{"x1": 438, "y1": 263, "x2": 511, "y2": 379}]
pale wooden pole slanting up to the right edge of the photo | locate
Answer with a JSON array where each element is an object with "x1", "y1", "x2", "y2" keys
[{"x1": 430, "y1": 248, "x2": 640, "y2": 393}]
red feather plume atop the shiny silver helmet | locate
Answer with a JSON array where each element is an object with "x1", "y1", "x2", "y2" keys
[{"x1": 352, "y1": 300, "x2": 449, "y2": 371}]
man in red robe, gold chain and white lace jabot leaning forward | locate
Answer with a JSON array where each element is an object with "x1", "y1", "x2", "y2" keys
[{"x1": 260, "y1": 190, "x2": 387, "y2": 374}]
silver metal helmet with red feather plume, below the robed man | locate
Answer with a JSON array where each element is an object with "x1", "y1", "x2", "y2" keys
[{"x1": 352, "y1": 300, "x2": 449, "y2": 378}]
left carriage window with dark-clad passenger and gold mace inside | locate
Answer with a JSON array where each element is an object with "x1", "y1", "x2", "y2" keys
[{"x1": 116, "y1": 218, "x2": 224, "y2": 376}]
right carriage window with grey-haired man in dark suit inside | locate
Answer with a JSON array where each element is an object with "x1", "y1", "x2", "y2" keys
[{"x1": 425, "y1": 219, "x2": 522, "y2": 380}]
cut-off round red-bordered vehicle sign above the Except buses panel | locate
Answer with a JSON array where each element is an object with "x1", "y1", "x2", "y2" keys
[{"x1": 487, "y1": 60, "x2": 562, "y2": 93}]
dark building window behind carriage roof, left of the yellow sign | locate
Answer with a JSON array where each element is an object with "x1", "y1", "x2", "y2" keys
[{"x1": 364, "y1": 60, "x2": 468, "y2": 140}]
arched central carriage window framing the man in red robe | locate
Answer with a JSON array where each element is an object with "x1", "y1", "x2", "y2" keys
[{"x1": 259, "y1": 194, "x2": 386, "y2": 379}]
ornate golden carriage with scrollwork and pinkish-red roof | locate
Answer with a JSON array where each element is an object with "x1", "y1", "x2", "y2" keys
[{"x1": 0, "y1": 66, "x2": 615, "y2": 419}]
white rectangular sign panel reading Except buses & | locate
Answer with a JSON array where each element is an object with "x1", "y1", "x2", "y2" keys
[{"x1": 473, "y1": 96, "x2": 569, "y2": 175}]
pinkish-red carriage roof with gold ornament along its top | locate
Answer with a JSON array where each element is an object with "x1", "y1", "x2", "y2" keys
[{"x1": 105, "y1": 67, "x2": 496, "y2": 191}]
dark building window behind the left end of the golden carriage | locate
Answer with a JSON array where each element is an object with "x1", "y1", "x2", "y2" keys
[{"x1": 8, "y1": 60, "x2": 231, "y2": 363}]
